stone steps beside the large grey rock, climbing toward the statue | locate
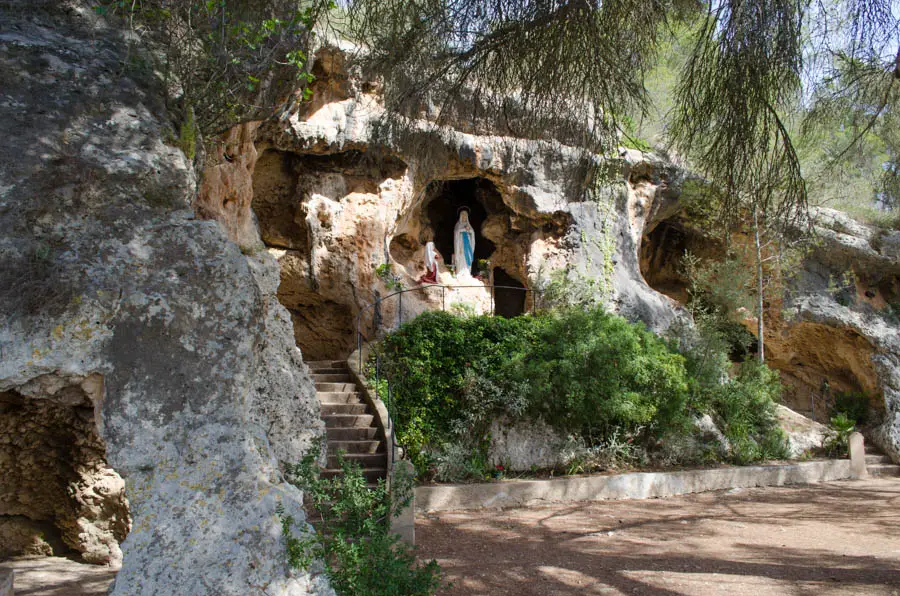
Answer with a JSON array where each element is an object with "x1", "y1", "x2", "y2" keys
[{"x1": 306, "y1": 360, "x2": 387, "y2": 486}]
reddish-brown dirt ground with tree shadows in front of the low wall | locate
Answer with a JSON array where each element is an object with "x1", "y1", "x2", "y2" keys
[{"x1": 416, "y1": 479, "x2": 900, "y2": 596}]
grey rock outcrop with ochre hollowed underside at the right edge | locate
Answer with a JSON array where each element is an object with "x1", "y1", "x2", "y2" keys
[{"x1": 788, "y1": 209, "x2": 900, "y2": 462}]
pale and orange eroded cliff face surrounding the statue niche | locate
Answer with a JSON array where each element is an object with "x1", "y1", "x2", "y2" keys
[{"x1": 207, "y1": 48, "x2": 681, "y2": 359}]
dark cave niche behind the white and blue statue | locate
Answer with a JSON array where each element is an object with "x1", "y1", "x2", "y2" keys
[{"x1": 425, "y1": 178, "x2": 504, "y2": 274}]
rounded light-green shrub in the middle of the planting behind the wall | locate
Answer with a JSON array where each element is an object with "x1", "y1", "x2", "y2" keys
[{"x1": 506, "y1": 308, "x2": 688, "y2": 439}]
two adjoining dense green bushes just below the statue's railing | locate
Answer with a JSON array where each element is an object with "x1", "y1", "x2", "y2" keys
[{"x1": 380, "y1": 308, "x2": 688, "y2": 480}]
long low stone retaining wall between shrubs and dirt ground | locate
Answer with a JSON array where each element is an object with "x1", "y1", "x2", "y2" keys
[{"x1": 416, "y1": 459, "x2": 850, "y2": 512}]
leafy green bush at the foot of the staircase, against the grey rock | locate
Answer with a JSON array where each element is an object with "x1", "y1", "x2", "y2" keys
[{"x1": 279, "y1": 454, "x2": 441, "y2": 596}]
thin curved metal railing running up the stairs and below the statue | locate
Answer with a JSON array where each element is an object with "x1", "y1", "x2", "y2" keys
[{"x1": 356, "y1": 284, "x2": 541, "y2": 461}]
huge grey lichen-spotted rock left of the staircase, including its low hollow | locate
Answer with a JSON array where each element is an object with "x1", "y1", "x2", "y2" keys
[{"x1": 0, "y1": 0, "x2": 330, "y2": 594}]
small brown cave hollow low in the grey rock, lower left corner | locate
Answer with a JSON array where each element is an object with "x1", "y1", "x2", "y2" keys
[{"x1": 0, "y1": 385, "x2": 131, "y2": 566}]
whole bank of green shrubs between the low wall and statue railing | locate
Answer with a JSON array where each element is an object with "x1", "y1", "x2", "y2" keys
[{"x1": 379, "y1": 307, "x2": 787, "y2": 481}]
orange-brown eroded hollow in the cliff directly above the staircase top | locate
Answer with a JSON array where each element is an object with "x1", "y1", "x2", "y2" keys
[{"x1": 252, "y1": 149, "x2": 406, "y2": 360}]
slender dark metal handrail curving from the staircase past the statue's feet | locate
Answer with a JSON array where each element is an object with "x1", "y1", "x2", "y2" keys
[{"x1": 356, "y1": 284, "x2": 541, "y2": 468}]
